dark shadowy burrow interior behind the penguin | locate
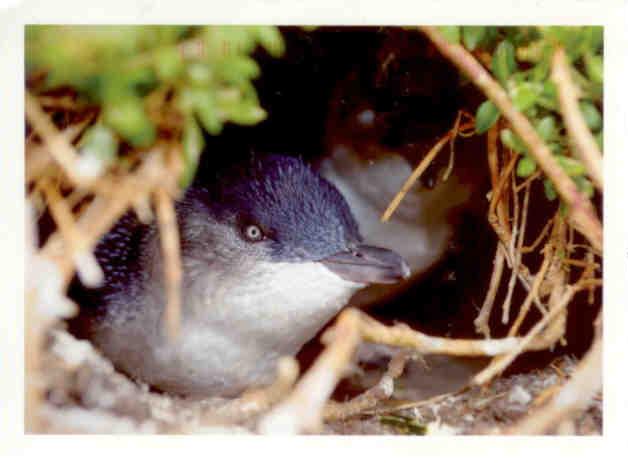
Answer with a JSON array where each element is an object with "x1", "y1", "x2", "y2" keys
[{"x1": 197, "y1": 27, "x2": 601, "y2": 397}]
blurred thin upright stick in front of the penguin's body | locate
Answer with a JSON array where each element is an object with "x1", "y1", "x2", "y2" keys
[{"x1": 154, "y1": 188, "x2": 183, "y2": 340}]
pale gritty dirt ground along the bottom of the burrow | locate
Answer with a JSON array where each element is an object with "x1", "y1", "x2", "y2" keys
[{"x1": 33, "y1": 329, "x2": 602, "y2": 435}]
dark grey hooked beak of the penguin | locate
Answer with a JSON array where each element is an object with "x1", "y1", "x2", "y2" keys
[{"x1": 320, "y1": 244, "x2": 410, "y2": 284}]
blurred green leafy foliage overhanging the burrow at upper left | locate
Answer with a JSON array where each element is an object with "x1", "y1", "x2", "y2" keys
[{"x1": 25, "y1": 25, "x2": 284, "y2": 184}]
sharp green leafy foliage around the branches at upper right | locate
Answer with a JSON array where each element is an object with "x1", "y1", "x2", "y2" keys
[{"x1": 441, "y1": 26, "x2": 604, "y2": 200}]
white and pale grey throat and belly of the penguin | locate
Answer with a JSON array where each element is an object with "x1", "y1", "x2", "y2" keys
[{"x1": 100, "y1": 263, "x2": 363, "y2": 396}]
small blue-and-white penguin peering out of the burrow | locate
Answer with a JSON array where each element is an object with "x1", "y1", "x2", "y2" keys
[{"x1": 71, "y1": 155, "x2": 409, "y2": 397}]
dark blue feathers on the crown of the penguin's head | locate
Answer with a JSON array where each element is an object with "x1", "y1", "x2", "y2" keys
[{"x1": 190, "y1": 155, "x2": 362, "y2": 261}]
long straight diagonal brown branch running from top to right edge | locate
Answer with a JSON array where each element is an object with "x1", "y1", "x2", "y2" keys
[{"x1": 420, "y1": 26, "x2": 603, "y2": 251}]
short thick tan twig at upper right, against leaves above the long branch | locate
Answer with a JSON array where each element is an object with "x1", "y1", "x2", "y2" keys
[{"x1": 552, "y1": 47, "x2": 604, "y2": 191}]
